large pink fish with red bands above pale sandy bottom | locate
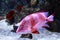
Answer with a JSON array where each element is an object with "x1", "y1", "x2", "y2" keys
[{"x1": 16, "y1": 12, "x2": 54, "y2": 34}]
